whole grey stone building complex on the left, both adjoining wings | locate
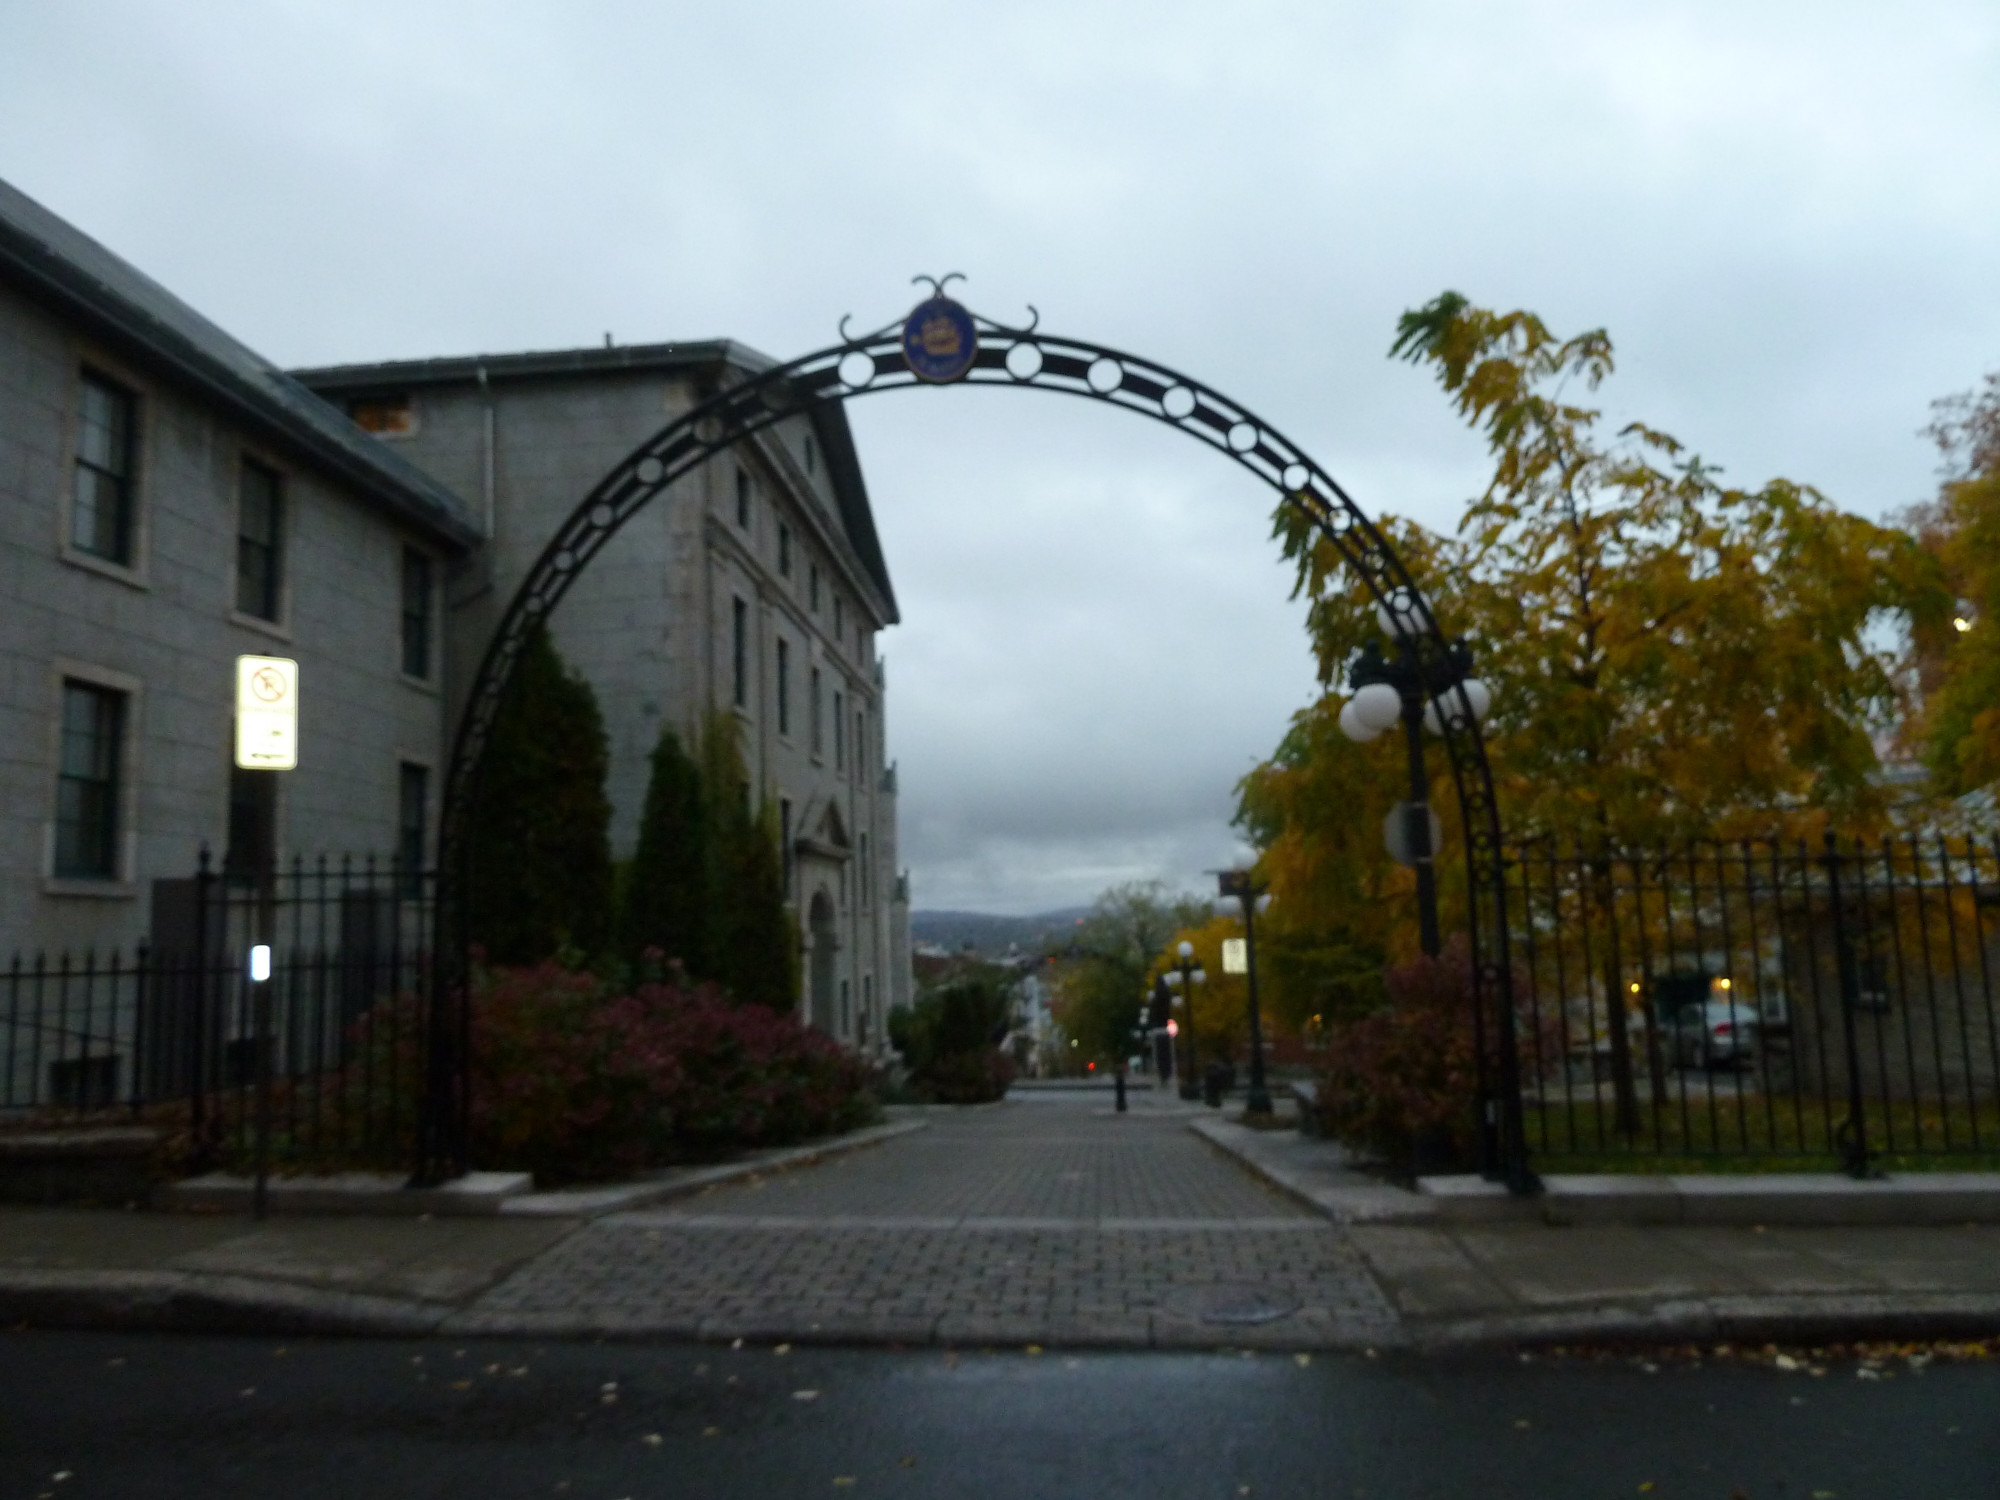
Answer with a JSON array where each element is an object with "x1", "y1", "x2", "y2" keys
[{"x1": 0, "y1": 184, "x2": 908, "y2": 1050}]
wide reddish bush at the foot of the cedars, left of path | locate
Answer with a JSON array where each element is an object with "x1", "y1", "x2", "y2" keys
[{"x1": 472, "y1": 964, "x2": 874, "y2": 1182}]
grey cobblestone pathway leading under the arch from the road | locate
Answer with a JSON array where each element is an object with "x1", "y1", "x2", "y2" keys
[{"x1": 460, "y1": 1096, "x2": 1396, "y2": 1348}]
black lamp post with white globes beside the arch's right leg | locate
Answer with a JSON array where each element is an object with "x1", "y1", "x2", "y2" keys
[{"x1": 1340, "y1": 590, "x2": 1492, "y2": 958}]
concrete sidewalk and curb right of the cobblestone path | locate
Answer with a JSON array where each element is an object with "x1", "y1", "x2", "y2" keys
[{"x1": 1190, "y1": 1114, "x2": 2000, "y2": 1348}]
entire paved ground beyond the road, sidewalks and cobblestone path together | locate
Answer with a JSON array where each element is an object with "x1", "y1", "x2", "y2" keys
[{"x1": 0, "y1": 1096, "x2": 2000, "y2": 1350}]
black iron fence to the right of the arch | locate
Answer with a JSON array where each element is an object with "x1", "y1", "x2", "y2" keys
[{"x1": 1510, "y1": 832, "x2": 2000, "y2": 1174}]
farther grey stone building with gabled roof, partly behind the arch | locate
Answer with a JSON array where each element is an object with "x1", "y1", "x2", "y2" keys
[{"x1": 294, "y1": 352, "x2": 908, "y2": 1050}]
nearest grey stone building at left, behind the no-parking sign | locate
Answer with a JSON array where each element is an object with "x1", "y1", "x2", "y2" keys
[{"x1": 0, "y1": 182, "x2": 480, "y2": 962}]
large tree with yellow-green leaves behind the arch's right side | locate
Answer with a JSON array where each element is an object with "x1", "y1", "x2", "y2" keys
[{"x1": 1240, "y1": 292, "x2": 1950, "y2": 1120}]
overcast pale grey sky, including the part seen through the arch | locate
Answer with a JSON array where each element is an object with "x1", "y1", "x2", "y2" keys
[{"x1": 0, "y1": 0, "x2": 2000, "y2": 912}]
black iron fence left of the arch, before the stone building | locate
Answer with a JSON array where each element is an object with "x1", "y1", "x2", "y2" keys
[{"x1": 0, "y1": 852, "x2": 436, "y2": 1170}]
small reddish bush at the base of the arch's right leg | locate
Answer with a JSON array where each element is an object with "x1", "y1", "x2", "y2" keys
[{"x1": 1318, "y1": 938, "x2": 1478, "y2": 1172}]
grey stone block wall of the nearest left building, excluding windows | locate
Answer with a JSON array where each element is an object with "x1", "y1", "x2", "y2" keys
[{"x1": 0, "y1": 288, "x2": 444, "y2": 954}]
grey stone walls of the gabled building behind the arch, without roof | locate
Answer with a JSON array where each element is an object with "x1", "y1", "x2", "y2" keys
[{"x1": 348, "y1": 366, "x2": 906, "y2": 1050}]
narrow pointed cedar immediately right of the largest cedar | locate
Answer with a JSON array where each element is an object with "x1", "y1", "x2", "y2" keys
[{"x1": 618, "y1": 728, "x2": 718, "y2": 978}]
